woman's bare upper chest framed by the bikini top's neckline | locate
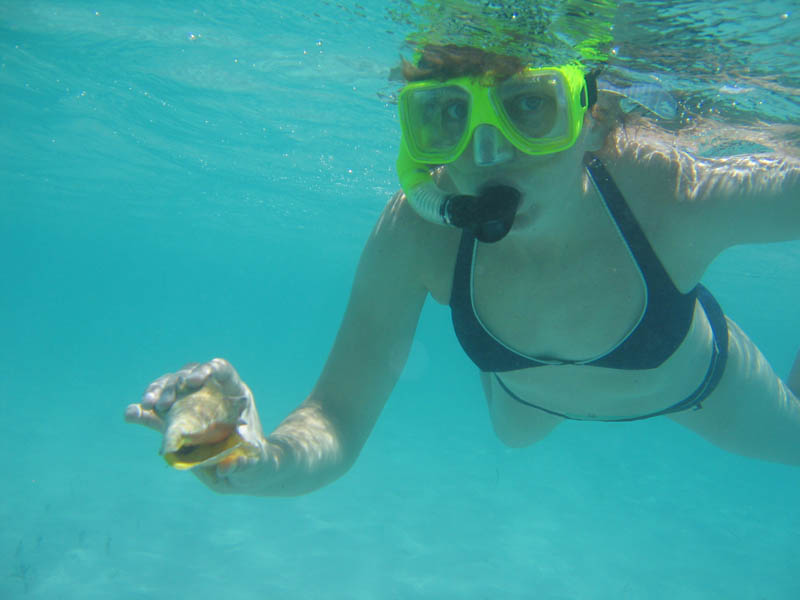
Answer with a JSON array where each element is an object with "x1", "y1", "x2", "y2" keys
[{"x1": 471, "y1": 220, "x2": 647, "y2": 360}]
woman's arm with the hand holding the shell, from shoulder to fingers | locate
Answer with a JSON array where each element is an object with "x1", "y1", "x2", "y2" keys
[{"x1": 126, "y1": 196, "x2": 434, "y2": 496}]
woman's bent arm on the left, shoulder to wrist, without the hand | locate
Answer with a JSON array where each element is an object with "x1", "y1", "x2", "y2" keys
[{"x1": 247, "y1": 197, "x2": 434, "y2": 495}]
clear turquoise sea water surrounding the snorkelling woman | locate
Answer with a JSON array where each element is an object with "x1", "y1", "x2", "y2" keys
[{"x1": 0, "y1": 1, "x2": 800, "y2": 600}]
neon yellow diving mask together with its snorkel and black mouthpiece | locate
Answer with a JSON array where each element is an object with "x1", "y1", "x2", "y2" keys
[{"x1": 397, "y1": 65, "x2": 596, "y2": 242}]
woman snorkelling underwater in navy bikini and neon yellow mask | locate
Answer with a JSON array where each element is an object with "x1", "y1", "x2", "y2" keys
[{"x1": 126, "y1": 47, "x2": 800, "y2": 495}]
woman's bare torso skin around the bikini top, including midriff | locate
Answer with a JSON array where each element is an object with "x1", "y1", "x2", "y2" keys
[{"x1": 418, "y1": 146, "x2": 712, "y2": 418}]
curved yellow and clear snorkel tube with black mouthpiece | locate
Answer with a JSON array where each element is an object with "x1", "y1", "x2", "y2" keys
[{"x1": 397, "y1": 140, "x2": 521, "y2": 244}]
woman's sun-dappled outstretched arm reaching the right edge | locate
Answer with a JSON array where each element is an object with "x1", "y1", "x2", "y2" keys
[{"x1": 602, "y1": 123, "x2": 800, "y2": 247}]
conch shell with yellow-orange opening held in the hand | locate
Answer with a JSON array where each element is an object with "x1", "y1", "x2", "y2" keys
[{"x1": 161, "y1": 380, "x2": 251, "y2": 470}]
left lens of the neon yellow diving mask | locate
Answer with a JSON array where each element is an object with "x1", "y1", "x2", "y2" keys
[{"x1": 404, "y1": 85, "x2": 470, "y2": 155}]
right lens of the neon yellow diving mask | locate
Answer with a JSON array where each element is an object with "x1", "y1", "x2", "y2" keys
[{"x1": 497, "y1": 73, "x2": 569, "y2": 140}]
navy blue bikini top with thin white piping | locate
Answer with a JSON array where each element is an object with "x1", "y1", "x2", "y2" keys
[{"x1": 450, "y1": 154, "x2": 698, "y2": 372}]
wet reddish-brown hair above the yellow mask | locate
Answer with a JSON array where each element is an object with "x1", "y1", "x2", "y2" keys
[{"x1": 402, "y1": 44, "x2": 525, "y2": 82}]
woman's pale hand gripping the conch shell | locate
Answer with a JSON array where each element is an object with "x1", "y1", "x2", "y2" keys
[{"x1": 125, "y1": 358, "x2": 266, "y2": 492}]
